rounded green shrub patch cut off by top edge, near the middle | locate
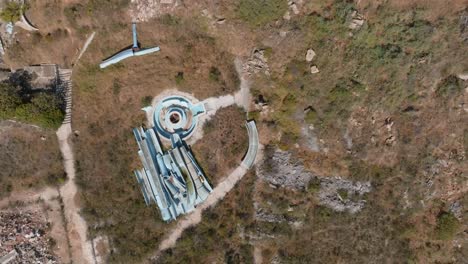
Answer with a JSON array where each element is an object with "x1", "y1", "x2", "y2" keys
[{"x1": 237, "y1": 0, "x2": 288, "y2": 27}]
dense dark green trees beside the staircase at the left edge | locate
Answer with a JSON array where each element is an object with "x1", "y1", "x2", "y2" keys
[{"x1": 0, "y1": 83, "x2": 64, "y2": 128}]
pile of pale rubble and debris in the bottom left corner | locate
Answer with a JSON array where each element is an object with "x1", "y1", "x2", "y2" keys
[{"x1": 0, "y1": 209, "x2": 58, "y2": 263}]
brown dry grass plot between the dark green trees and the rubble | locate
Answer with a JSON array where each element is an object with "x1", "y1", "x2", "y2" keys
[{"x1": 0, "y1": 121, "x2": 65, "y2": 197}]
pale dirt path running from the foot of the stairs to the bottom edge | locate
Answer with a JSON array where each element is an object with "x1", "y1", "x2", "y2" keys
[{"x1": 57, "y1": 123, "x2": 94, "y2": 263}]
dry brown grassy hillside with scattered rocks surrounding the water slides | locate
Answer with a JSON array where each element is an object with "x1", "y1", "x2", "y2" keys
[{"x1": 1, "y1": 0, "x2": 468, "y2": 263}]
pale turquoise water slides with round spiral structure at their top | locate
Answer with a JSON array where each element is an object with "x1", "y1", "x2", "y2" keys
[{"x1": 133, "y1": 96, "x2": 213, "y2": 221}]
